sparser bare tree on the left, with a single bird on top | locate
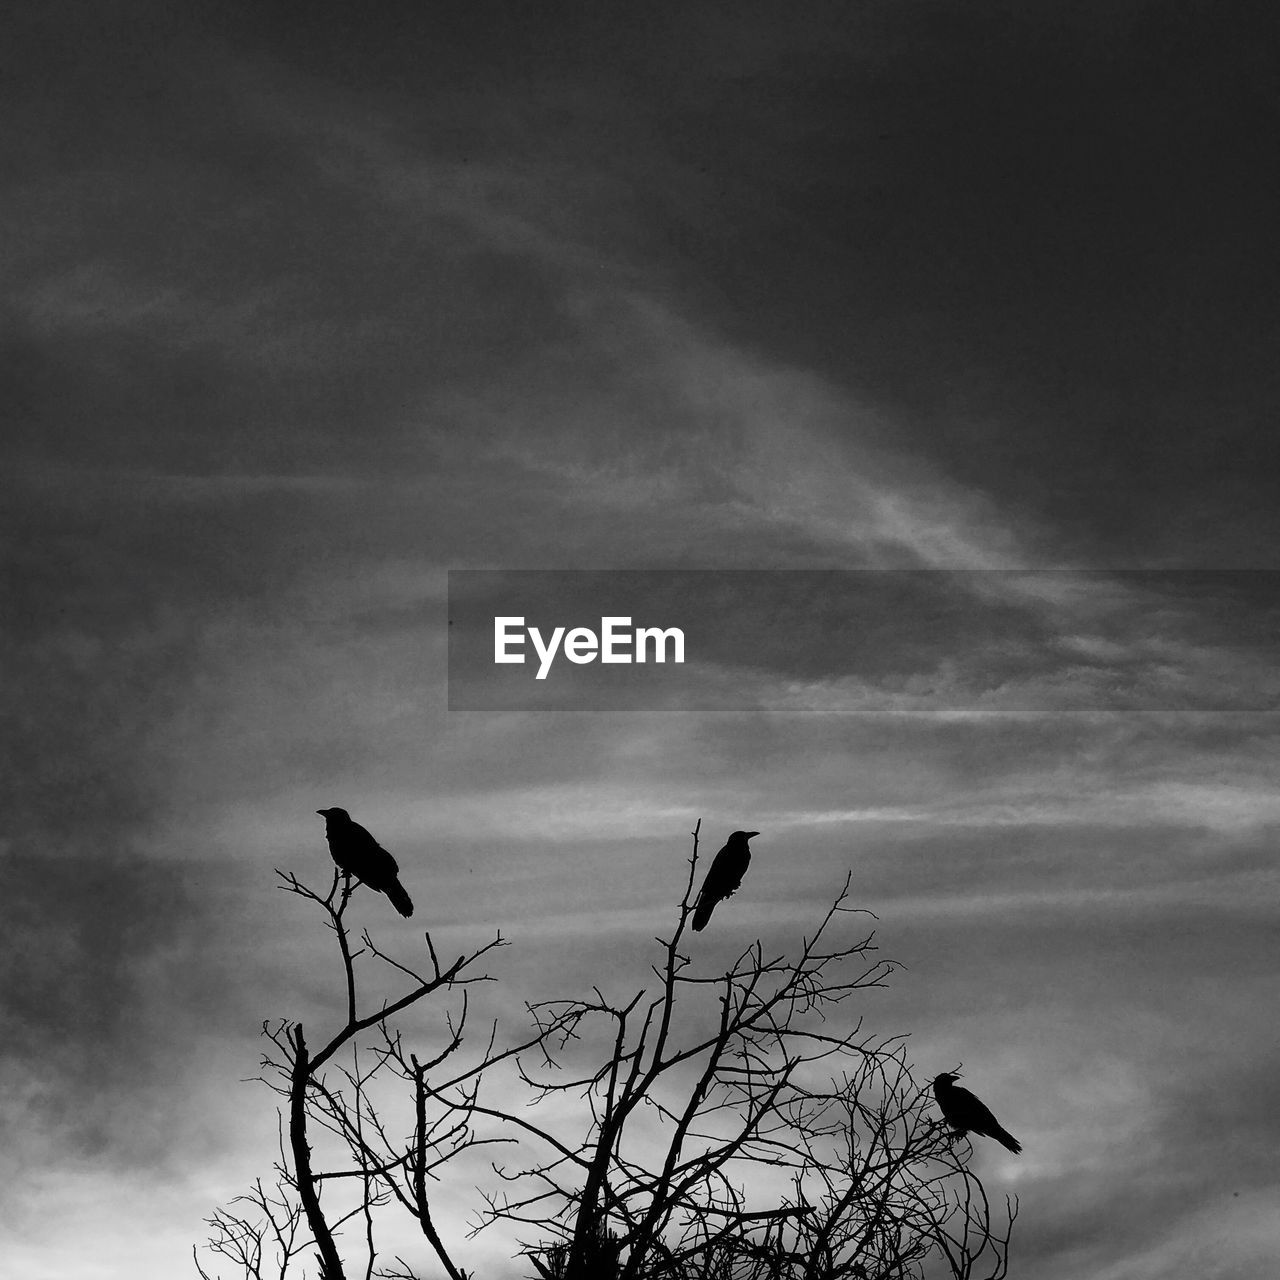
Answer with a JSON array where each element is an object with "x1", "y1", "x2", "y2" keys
[{"x1": 196, "y1": 872, "x2": 555, "y2": 1280}]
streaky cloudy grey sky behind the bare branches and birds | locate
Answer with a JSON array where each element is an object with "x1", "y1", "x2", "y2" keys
[{"x1": 0, "y1": 0, "x2": 1280, "y2": 1280}]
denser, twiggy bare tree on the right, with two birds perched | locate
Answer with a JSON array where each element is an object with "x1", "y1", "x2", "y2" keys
[{"x1": 476, "y1": 828, "x2": 1016, "y2": 1280}]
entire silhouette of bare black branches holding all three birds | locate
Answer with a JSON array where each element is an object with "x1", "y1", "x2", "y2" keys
[{"x1": 197, "y1": 824, "x2": 1016, "y2": 1280}]
